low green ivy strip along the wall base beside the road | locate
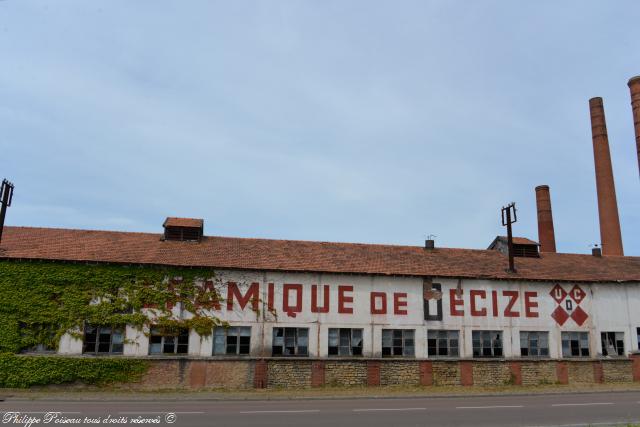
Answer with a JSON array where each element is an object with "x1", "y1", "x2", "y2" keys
[{"x1": 0, "y1": 354, "x2": 148, "y2": 388}]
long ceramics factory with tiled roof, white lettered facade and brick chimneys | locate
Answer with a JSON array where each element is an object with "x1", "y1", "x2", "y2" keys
[{"x1": 0, "y1": 77, "x2": 640, "y2": 392}]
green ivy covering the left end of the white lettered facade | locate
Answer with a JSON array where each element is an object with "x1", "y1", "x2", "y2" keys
[{"x1": 0, "y1": 261, "x2": 229, "y2": 353}]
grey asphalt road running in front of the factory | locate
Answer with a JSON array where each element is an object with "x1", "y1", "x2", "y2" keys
[{"x1": 0, "y1": 392, "x2": 640, "y2": 427}]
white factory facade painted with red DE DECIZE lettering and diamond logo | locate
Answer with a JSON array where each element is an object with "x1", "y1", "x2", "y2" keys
[{"x1": 59, "y1": 272, "x2": 640, "y2": 358}]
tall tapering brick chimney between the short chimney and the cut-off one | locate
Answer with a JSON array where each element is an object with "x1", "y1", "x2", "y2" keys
[{"x1": 589, "y1": 97, "x2": 624, "y2": 256}]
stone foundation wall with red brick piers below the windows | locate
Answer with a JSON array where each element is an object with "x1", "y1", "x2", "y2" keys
[{"x1": 65, "y1": 357, "x2": 640, "y2": 390}]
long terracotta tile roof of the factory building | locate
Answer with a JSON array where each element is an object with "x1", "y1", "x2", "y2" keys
[{"x1": 0, "y1": 227, "x2": 640, "y2": 282}]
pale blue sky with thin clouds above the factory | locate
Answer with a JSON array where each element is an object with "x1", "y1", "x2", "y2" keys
[{"x1": 0, "y1": 0, "x2": 640, "y2": 256}]
